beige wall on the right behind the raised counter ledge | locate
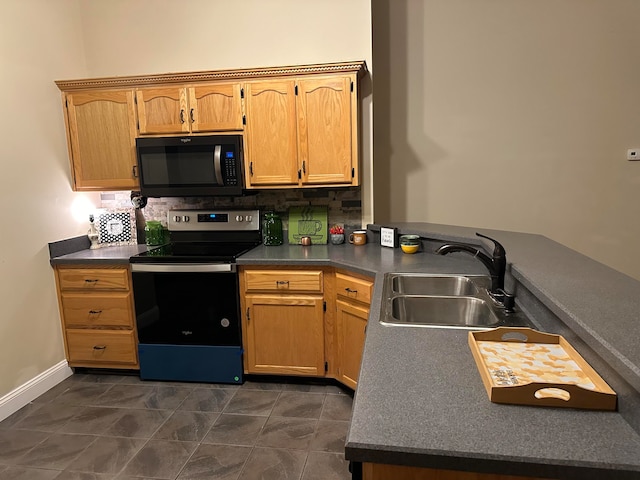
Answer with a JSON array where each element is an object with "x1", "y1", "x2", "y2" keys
[{"x1": 372, "y1": 0, "x2": 640, "y2": 279}]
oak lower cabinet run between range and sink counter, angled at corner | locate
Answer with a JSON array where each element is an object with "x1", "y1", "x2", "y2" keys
[{"x1": 240, "y1": 266, "x2": 373, "y2": 389}]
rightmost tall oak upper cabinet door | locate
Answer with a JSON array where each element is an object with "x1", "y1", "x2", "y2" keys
[{"x1": 297, "y1": 76, "x2": 355, "y2": 185}]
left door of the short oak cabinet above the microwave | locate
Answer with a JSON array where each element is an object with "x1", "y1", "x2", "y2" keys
[{"x1": 136, "y1": 87, "x2": 189, "y2": 135}]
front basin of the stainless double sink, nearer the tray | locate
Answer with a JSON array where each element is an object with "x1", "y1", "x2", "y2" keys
[{"x1": 382, "y1": 295, "x2": 500, "y2": 328}]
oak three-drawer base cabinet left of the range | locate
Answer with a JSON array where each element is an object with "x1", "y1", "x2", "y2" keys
[{"x1": 56, "y1": 265, "x2": 139, "y2": 369}]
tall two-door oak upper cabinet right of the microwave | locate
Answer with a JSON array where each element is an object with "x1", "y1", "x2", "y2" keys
[{"x1": 245, "y1": 74, "x2": 358, "y2": 188}]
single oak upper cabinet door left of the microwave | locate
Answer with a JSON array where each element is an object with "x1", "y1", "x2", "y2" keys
[{"x1": 66, "y1": 90, "x2": 139, "y2": 191}]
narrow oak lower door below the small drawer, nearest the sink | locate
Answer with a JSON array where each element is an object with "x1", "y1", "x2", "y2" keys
[{"x1": 336, "y1": 300, "x2": 369, "y2": 390}]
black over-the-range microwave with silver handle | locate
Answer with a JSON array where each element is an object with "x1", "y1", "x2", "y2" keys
[{"x1": 136, "y1": 135, "x2": 244, "y2": 197}]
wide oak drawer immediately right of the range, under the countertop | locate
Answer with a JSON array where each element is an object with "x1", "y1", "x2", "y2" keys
[{"x1": 244, "y1": 270, "x2": 322, "y2": 293}]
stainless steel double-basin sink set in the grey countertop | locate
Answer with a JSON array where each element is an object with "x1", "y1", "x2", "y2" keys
[{"x1": 380, "y1": 273, "x2": 531, "y2": 330}]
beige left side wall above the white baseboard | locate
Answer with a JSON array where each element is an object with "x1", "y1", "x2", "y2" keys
[{"x1": 0, "y1": 0, "x2": 97, "y2": 397}]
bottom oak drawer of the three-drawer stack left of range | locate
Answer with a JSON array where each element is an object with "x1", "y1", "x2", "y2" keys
[{"x1": 66, "y1": 330, "x2": 138, "y2": 365}]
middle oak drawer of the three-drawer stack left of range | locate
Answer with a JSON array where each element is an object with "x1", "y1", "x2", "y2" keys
[{"x1": 61, "y1": 292, "x2": 133, "y2": 328}]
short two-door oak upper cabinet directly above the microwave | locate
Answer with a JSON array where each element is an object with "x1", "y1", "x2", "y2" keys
[{"x1": 136, "y1": 83, "x2": 242, "y2": 135}]
